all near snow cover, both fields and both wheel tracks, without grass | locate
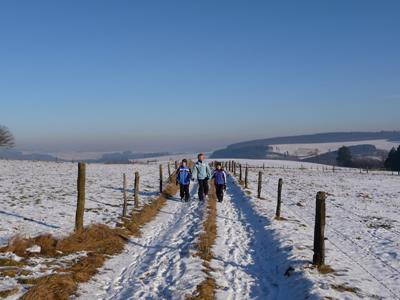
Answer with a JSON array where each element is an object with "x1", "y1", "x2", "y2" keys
[{"x1": 0, "y1": 160, "x2": 400, "y2": 300}]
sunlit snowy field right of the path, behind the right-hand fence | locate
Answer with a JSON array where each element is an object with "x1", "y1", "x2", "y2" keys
[{"x1": 228, "y1": 160, "x2": 400, "y2": 299}]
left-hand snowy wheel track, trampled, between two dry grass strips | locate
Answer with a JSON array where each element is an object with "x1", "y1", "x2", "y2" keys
[{"x1": 78, "y1": 187, "x2": 204, "y2": 299}]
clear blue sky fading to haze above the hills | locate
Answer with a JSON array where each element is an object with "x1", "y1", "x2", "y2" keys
[{"x1": 0, "y1": 0, "x2": 400, "y2": 151}]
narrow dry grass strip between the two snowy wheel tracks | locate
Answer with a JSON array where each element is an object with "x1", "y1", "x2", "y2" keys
[{"x1": 187, "y1": 184, "x2": 217, "y2": 300}]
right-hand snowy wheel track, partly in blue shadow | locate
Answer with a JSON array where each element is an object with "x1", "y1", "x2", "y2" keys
[{"x1": 211, "y1": 178, "x2": 317, "y2": 299}]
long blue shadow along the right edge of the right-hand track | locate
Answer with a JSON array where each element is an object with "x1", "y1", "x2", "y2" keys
[{"x1": 223, "y1": 178, "x2": 319, "y2": 299}]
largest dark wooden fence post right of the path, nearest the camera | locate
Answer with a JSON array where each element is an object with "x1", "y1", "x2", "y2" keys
[{"x1": 313, "y1": 192, "x2": 326, "y2": 266}]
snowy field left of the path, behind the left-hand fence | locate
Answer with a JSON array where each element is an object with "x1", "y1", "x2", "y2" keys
[{"x1": 0, "y1": 160, "x2": 163, "y2": 245}]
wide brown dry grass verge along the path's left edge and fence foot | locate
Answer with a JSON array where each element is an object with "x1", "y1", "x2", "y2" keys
[{"x1": 5, "y1": 173, "x2": 178, "y2": 300}]
